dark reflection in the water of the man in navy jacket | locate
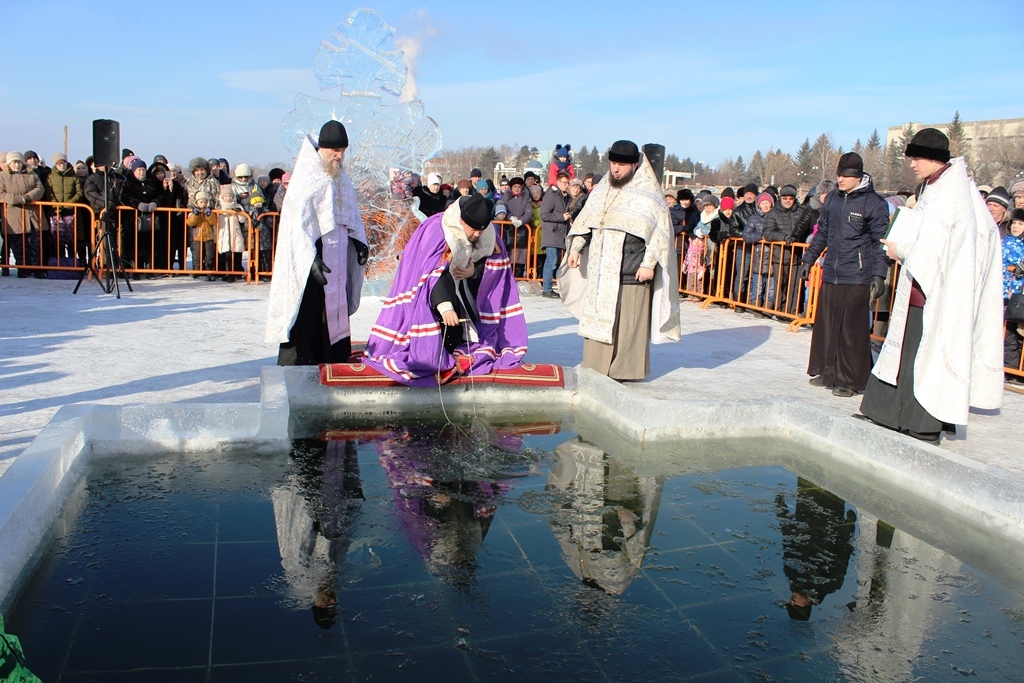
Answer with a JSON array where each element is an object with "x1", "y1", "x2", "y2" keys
[{"x1": 775, "y1": 477, "x2": 857, "y2": 622}]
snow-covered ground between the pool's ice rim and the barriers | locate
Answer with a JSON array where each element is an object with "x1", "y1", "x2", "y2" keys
[{"x1": 0, "y1": 276, "x2": 1024, "y2": 478}]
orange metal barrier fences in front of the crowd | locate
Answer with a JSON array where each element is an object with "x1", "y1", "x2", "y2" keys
[{"x1": 0, "y1": 202, "x2": 1024, "y2": 378}]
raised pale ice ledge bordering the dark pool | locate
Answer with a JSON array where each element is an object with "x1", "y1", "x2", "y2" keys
[{"x1": 0, "y1": 367, "x2": 1024, "y2": 610}]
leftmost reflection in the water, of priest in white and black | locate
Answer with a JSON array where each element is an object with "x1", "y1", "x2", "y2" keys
[{"x1": 270, "y1": 439, "x2": 364, "y2": 629}]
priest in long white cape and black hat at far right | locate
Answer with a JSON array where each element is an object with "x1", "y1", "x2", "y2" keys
[{"x1": 860, "y1": 128, "x2": 1002, "y2": 441}]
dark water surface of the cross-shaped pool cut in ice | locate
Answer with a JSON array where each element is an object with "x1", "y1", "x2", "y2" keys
[{"x1": 7, "y1": 430, "x2": 1024, "y2": 682}]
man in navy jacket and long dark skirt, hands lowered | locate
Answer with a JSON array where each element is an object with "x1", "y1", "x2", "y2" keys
[{"x1": 799, "y1": 152, "x2": 889, "y2": 397}]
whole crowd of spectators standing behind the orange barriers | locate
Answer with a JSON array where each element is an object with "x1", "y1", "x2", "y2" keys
[{"x1": 0, "y1": 144, "x2": 1024, "y2": 374}]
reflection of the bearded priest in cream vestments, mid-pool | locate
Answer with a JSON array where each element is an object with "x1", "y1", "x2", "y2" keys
[{"x1": 547, "y1": 438, "x2": 665, "y2": 595}]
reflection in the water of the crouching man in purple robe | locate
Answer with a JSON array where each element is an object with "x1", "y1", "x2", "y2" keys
[{"x1": 377, "y1": 425, "x2": 522, "y2": 586}]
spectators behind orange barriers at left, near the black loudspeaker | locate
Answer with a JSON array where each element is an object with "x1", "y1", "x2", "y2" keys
[{"x1": 0, "y1": 148, "x2": 290, "y2": 282}]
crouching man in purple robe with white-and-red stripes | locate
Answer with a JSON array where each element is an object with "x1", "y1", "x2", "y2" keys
[{"x1": 364, "y1": 193, "x2": 526, "y2": 387}]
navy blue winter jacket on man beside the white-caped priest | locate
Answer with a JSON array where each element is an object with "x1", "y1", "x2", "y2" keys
[{"x1": 803, "y1": 173, "x2": 889, "y2": 285}]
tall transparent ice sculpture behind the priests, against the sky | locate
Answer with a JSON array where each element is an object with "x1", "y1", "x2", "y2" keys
[{"x1": 282, "y1": 9, "x2": 441, "y2": 278}]
